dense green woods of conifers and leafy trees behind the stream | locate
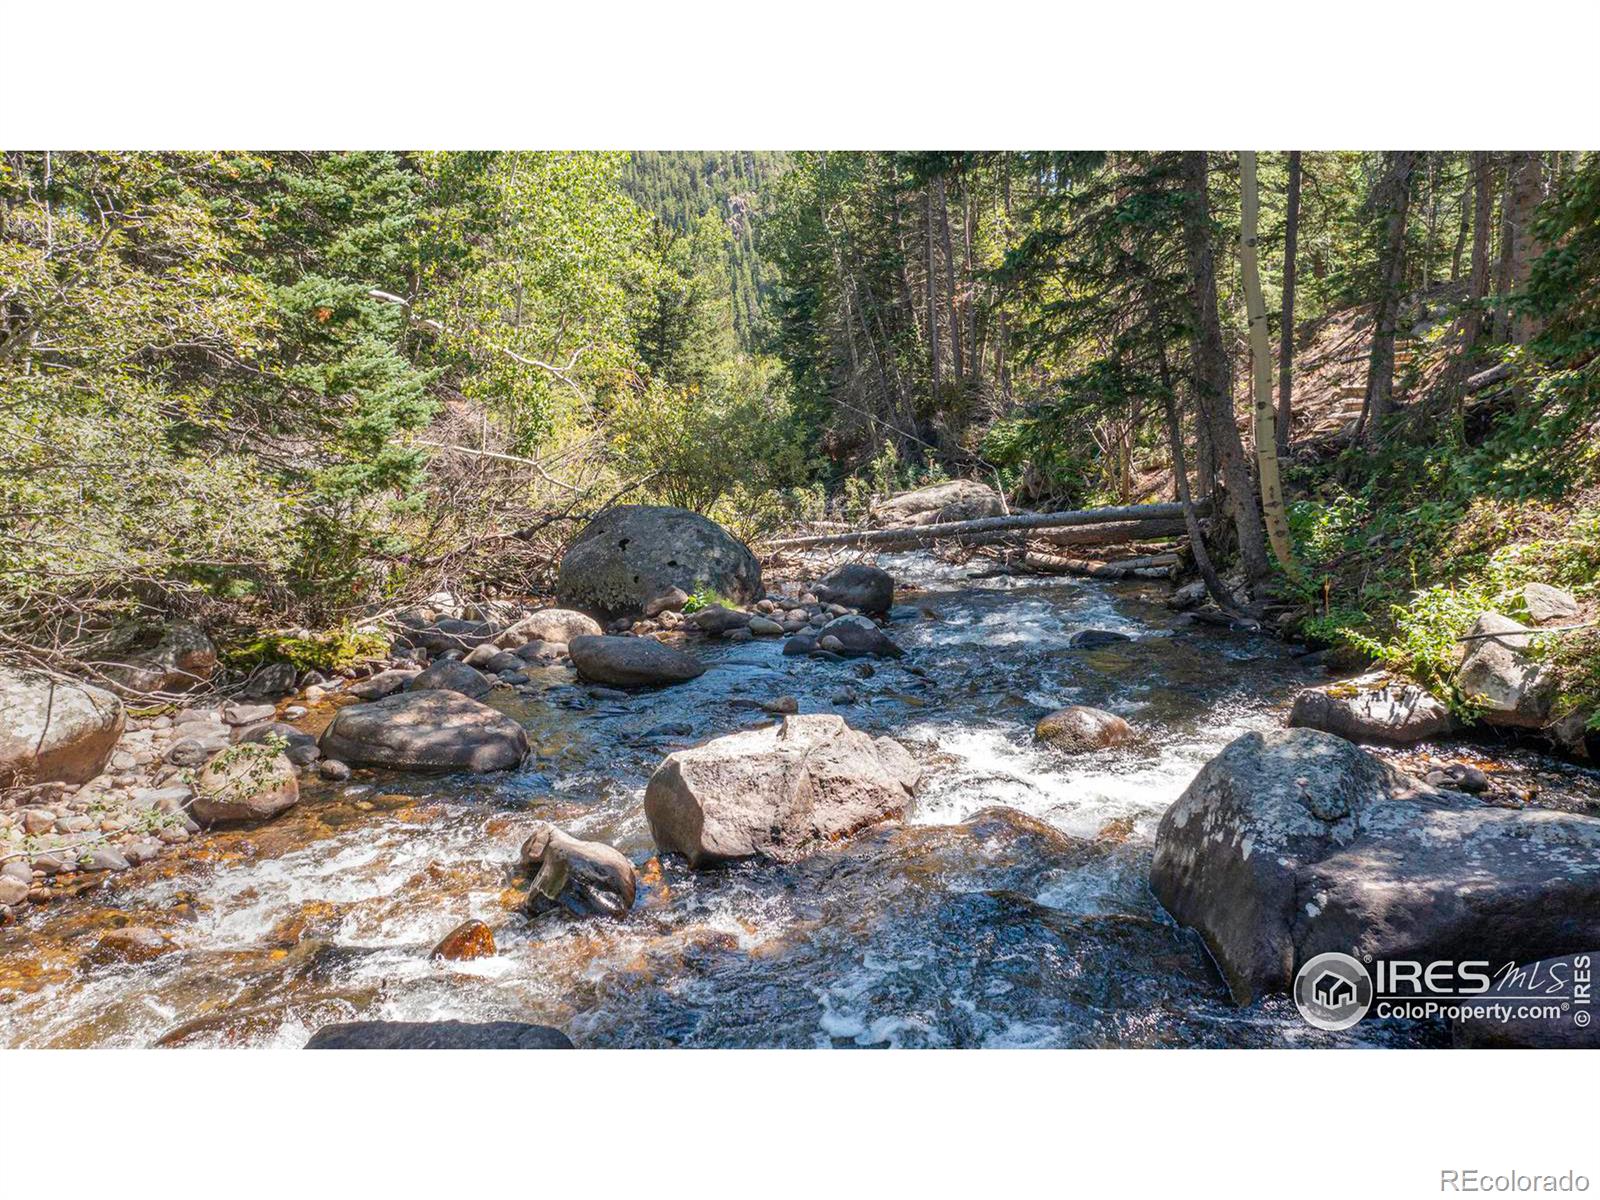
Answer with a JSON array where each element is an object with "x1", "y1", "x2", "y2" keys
[{"x1": 0, "y1": 150, "x2": 1600, "y2": 729}]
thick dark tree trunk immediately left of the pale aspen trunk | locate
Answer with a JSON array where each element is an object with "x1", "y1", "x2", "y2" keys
[{"x1": 1182, "y1": 150, "x2": 1269, "y2": 584}]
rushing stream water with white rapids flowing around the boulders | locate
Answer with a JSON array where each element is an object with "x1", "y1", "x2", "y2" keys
[{"x1": 0, "y1": 555, "x2": 1574, "y2": 1046}]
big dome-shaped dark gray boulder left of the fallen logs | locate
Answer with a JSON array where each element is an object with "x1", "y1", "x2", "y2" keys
[{"x1": 555, "y1": 504, "x2": 762, "y2": 619}]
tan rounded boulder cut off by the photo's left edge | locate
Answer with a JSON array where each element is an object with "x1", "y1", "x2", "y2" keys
[{"x1": 0, "y1": 667, "x2": 125, "y2": 787}]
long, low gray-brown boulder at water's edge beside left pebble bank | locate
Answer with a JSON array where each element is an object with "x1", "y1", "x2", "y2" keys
[{"x1": 320, "y1": 688, "x2": 528, "y2": 771}]
